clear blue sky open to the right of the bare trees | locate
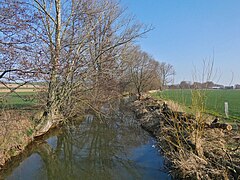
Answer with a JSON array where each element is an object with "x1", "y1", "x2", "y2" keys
[{"x1": 121, "y1": 0, "x2": 240, "y2": 85}]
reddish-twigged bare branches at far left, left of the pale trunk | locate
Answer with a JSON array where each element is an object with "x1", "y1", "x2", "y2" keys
[{"x1": 0, "y1": 0, "x2": 45, "y2": 102}]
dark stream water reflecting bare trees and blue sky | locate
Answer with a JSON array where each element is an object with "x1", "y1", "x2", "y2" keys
[{"x1": 0, "y1": 104, "x2": 171, "y2": 180}]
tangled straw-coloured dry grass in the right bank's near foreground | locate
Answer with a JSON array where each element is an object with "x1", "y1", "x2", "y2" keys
[{"x1": 157, "y1": 112, "x2": 240, "y2": 179}]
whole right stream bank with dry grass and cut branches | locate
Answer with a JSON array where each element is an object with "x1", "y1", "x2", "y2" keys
[{"x1": 132, "y1": 96, "x2": 240, "y2": 180}]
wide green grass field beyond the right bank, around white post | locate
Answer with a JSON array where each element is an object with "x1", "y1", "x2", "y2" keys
[{"x1": 152, "y1": 90, "x2": 240, "y2": 120}]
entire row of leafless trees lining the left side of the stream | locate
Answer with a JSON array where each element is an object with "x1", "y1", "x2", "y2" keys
[{"x1": 0, "y1": 0, "x2": 175, "y2": 133}]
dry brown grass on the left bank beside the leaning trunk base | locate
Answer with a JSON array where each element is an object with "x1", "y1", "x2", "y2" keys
[{"x1": 0, "y1": 109, "x2": 33, "y2": 168}]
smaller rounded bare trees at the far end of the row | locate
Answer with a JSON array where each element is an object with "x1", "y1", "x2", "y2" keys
[{"x1": 120, "y1": 46, "x2": 175, "y2": 98}]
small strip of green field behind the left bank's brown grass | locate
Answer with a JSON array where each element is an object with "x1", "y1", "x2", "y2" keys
[{"x1": 0, "y1": 92, "x2": 37, "y2": 109}]
